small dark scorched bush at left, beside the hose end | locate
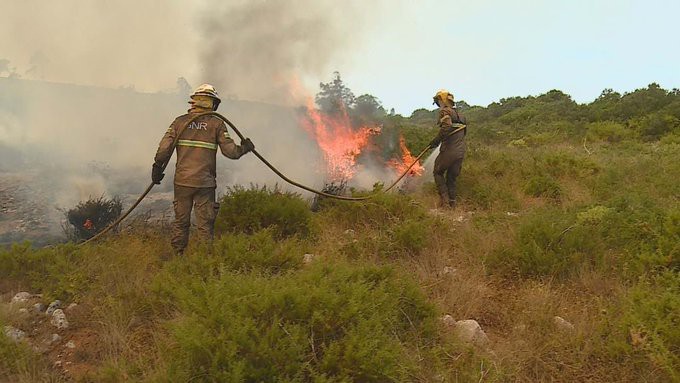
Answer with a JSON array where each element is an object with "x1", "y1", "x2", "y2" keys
[{"x1": 65, "y1": 196, "x2": 123, "y2": 241}]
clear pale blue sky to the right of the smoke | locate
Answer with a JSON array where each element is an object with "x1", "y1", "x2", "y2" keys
[{"x1": 340, "y1": 0, "x2": 680, "y2": 113}]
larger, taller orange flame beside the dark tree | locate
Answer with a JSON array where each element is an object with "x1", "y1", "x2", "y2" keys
[{"x1": 301, "y1": 98, "x2": 380, "y2": 182}]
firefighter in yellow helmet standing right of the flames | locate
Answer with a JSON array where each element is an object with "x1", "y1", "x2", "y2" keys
[{"x1": 430, "y1": 90, "x2": 467, "y2": 207}]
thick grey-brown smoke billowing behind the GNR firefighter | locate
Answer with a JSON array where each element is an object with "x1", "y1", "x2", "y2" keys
[{"x1": 0, "y1": 0, "x2": 382, "y2": 243}]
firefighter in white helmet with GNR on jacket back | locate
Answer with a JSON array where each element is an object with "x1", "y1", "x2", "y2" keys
[{"x1": 151, "y1": 84, "x2": 255, "y2": 255}]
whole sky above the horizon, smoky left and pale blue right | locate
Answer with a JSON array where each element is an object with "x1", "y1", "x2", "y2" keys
[{"x1": 0, "y1": 0, "x2": 680, "y2": 115}]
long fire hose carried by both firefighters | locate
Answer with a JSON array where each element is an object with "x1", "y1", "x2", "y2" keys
[{"x1": 80, "y1": 112, "x2": 432, "y2": 245}]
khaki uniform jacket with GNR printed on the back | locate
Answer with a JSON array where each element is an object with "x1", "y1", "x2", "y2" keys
[{"x1": 155, "y1": 112, "x2": 244, "y2": 188}]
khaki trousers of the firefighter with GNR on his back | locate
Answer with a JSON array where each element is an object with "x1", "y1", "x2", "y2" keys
[{"x1": 172, "y1": 185, "x2": 219, "y2": 253}]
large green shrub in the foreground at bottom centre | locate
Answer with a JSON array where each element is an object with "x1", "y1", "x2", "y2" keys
[{"x1": 155, "y1": 263, "x2": 436, "y2": 382}]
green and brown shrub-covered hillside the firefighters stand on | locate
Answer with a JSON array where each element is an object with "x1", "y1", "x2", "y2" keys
[{"x1": 0, "y1": 84, "x2": 680, "y2": 382}]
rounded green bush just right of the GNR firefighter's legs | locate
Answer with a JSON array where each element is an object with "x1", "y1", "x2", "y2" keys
[{"x1": 215, "y1": 186, "x2": 312, "y2": 238}]
